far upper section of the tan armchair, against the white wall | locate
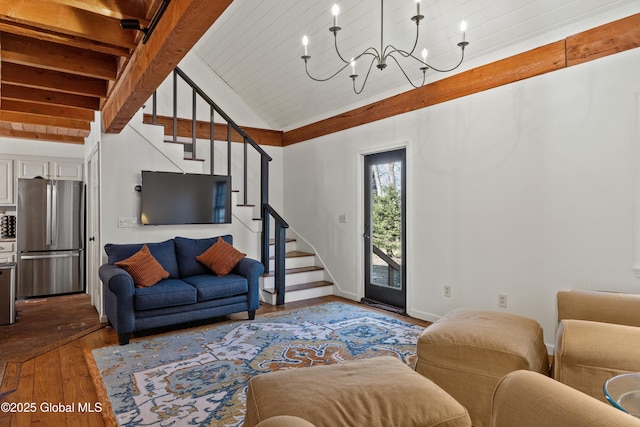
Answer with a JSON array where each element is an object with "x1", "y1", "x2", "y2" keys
[{"x1": 557, "y1": 290, "x2": 640, "y2": 326}]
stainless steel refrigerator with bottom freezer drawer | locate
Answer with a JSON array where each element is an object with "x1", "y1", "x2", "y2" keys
[{"x1": 16, "y1": 178, "x2": 84, "y2": 298}]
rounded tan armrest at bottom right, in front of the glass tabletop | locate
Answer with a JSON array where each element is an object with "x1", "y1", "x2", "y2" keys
[{"x1": 491, "y1": 371, "x2": 640, "y2": 427}]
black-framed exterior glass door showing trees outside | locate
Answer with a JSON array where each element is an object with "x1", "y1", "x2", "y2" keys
[{"x1": 363, "y1": 149, "x2": 407, "y2": 313}]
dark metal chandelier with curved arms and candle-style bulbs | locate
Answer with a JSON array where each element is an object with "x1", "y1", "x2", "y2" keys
[{"x1": 302, "y1": 0, "x2": 469, "y2": 94}]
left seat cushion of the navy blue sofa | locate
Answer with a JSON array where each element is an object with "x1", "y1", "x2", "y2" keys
[{"x1": 133, "y1": 279, "x2": 197, "y2": 310}]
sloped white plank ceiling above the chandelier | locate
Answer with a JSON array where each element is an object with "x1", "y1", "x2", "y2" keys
[{"x1": 193, "y1": 0, "x2": 640, "y2": 130}]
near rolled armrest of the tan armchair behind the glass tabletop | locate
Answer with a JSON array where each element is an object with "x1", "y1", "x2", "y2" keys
[{"x1": 553, "y1": 319, "x2": 640, "y2": 402}]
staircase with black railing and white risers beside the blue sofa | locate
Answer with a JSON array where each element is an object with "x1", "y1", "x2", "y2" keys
[{"x1": 151, "y1": 68, "x2": 333, "y2": 305}]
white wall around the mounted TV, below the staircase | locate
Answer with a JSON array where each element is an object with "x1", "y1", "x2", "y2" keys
[{"x1": 100, "y1": 111, "x2": 283, "y2": 259}]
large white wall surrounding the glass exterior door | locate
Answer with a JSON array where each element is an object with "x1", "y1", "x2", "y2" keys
[{"x1": 284, "y1": 49, "x2": 640, "y2": 344}]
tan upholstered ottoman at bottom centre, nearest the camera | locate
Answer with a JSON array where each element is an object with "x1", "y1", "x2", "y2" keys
[{"x1": 244, "y1": 356, "x2": 471, "y2": 427}]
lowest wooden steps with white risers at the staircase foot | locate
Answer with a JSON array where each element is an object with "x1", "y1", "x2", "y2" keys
[{"x1": 261, "y1": 238, "x2": 333, "y2": 305}]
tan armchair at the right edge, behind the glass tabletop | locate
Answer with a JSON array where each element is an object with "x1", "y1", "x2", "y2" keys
[{"x1": 553, "y1": 290, "x2": 640, "y2": 402}]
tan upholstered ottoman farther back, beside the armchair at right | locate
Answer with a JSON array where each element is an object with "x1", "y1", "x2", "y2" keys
[{"x1": 416, "y1": 309, "x2": 549, "y2": 427}]
